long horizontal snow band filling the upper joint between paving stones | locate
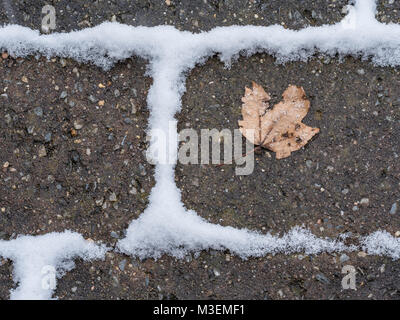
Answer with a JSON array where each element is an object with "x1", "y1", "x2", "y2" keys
[{"x1": 0, "y1": 0, "x2": 400, "y2": 69}]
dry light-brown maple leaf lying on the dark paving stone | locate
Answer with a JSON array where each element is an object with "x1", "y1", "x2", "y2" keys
[{"x1": 239, "y1": 82, "x2": 319, "y2": 159}]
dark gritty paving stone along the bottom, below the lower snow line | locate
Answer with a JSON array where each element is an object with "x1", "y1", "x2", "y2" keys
[{"x1": 56, "y1": 251, "x2": 400, "y2": 300}]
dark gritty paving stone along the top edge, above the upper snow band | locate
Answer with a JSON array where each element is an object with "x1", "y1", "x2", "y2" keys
[{"x1": 0, "y1": 0, "x2": 347, "y2": 32}]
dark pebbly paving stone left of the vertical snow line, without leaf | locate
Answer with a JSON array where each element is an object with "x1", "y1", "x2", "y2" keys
[{"x1": 0, "y1": 58, "x2": 153, "y2": 242}]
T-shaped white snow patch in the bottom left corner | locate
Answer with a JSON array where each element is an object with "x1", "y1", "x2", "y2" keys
[{"x1": 0, "y1": 231, "x2": 107, "y2": 300}]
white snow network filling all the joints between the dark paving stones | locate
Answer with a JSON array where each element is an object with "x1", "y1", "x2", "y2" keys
[{"x1": 0, "y1": 0, "x2": 400, "y2": 299}]
